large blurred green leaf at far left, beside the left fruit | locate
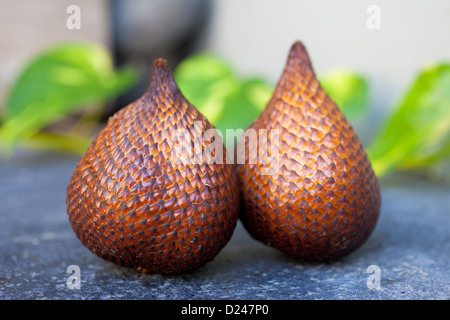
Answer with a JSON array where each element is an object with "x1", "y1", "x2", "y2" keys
[{"x1": 0, "y1": 43, "x2": 137, "y2": 147}]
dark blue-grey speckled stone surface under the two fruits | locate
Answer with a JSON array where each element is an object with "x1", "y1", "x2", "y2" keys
[{"x1": 0, "y1": 153, "x2": 450, "y2": 300}]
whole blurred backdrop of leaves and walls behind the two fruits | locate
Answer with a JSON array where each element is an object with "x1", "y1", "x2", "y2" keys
[{"x1": 0, "y1": 0, "x2": 450, "y2": 182}]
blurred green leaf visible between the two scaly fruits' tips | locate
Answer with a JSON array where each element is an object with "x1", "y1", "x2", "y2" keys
[{"x1": 174, "y1": 53, "x2": 273, "y2": 143}]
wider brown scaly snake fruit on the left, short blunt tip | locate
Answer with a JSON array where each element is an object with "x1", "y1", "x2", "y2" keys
[{"x1": 66, "y1": 59, "x2": 239, "y2": 274}]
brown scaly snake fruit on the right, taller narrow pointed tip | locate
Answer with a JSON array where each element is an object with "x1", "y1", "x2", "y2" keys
[{"x1": 237, "y1": 42, "x2": 380, "y2": 261}]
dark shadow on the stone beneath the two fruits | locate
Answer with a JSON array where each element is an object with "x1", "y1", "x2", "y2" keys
[{"x1": 96, "y1": 221, "x2": 383, "y2": 286}]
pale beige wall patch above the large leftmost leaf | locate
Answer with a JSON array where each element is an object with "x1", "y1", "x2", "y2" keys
[{"x1": 0, "y1": 0, "x2": 111, "y2": 109}]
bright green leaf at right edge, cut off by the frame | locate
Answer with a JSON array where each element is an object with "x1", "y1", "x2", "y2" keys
[{"x1": 368, "y1": 63, "x2": 450, "y2": 175}]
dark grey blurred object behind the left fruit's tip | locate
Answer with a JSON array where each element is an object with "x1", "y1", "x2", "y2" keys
[{"x1": 105, "y1": 0, "x2": 211, "y2": 119}]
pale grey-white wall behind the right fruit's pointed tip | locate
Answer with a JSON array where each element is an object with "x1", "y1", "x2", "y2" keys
[{"x1": 202, "y1": 0, "x2": 450, "y2": 141}]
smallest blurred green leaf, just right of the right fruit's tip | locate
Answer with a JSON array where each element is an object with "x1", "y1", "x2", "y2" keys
[{"x1": 319, "y1": 69, "x2": 369, "y2": 121}]
